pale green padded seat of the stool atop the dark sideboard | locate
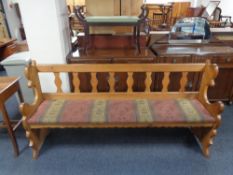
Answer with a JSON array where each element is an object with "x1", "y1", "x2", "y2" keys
[{"x1": 85, "y1": 16, "x2": 139, "y2": 24}]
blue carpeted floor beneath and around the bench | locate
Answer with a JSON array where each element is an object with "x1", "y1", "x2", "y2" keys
[{"x1": 0, "y1": 70, "x2": 233, "y2": 175}]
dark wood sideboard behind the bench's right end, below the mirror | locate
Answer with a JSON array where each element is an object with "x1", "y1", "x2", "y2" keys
[{"x1": 151, "y1": 43, "x2": 233, "y2": 101}]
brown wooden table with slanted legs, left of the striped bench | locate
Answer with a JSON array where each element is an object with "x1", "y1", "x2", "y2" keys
[{"x1": 0, "y1": 77, "x2": 23, "y2": 156}]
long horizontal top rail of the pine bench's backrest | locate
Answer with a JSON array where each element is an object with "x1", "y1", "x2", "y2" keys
[{"x1": 36, "y1": 63, "x2": 206, "y2": 72}]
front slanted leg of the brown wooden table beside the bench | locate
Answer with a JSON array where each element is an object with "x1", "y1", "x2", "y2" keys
[{"x1": 0, "y1": 104, "x2": 19, "y2": 156}]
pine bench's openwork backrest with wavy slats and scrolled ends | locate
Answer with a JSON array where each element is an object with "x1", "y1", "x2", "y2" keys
[{"x1": 26, "y1": 62, "x2": 218, "y2": 99}]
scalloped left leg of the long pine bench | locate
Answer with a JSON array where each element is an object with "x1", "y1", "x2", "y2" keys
[{"x1": 26, "y1": 129, "x2": 49, "y2": 159}]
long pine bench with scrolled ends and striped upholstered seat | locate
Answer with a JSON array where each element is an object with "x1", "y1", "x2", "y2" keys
[{"x1": 20, "y1": 61, "x2": 223, "y2": 159}]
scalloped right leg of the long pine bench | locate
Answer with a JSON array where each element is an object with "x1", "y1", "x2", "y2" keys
[{"x1": 191, "y1": 127, "x2": 217, "y2": 157}]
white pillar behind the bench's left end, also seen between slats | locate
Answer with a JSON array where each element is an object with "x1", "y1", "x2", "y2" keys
[{"x1": 19, "y1": 0, "x2": 71, "y2": 92}]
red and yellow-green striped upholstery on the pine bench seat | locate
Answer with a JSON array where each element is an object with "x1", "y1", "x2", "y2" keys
[{"x1": 28, "y1": 99, "x2": 214, "y2": 124}]
